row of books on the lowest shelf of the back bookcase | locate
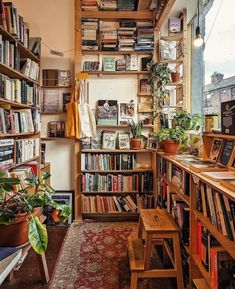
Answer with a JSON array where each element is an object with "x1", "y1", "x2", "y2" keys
[{"x1": 82, "y1": 195, "x2": 154, "y2": 213}]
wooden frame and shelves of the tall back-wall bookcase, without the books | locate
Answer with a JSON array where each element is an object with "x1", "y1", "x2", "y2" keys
[{"x1": 75, "y1": 1, "x2": 156, "y2": 220}]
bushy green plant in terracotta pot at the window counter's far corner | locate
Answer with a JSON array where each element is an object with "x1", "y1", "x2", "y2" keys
[{"x1": 154, "y1": 127, "x2": 185, "y2": 154}]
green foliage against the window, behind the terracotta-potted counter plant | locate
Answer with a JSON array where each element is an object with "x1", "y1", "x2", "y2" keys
[{"x1": 175, "y1": 110, "x2": 202, "y2": 131}]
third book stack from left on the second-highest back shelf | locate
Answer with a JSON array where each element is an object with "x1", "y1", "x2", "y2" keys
[{"x1": 118, "y1": 21, "x2": 136, "y2": 51}]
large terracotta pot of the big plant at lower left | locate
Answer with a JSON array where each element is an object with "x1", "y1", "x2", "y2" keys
[{"x1": 0, "y1": 208, "x2": 40, "y2": 247}]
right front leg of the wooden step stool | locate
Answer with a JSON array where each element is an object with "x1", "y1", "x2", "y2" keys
[{"x1": 173, "y1": 232, "x2": 184, "y2": 289}]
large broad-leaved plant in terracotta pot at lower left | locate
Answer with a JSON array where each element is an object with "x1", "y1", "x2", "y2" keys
[{"x1": 0, "y1": 171, "x2": 70, "y2": 254}]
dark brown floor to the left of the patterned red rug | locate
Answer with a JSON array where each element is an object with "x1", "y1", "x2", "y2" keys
[{"x1": 1, "y1": 226, "x2": 67, "y2": 289}]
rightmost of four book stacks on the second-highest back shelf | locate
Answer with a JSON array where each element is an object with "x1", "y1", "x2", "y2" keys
[{"x1": 135, "y1": 22, "x2": 154, "y2": 51}]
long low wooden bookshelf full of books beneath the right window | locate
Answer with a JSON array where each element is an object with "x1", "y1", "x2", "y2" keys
[{"x1": 157, "y1": 134, "x2": 235, "y2": 289}]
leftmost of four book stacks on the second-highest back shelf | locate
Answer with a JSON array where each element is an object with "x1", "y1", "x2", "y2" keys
[{"x1": 81, "y1": 18, "x2": 99, "y2": 50}]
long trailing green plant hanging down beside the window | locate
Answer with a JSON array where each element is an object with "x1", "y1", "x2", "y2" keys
[{"x1": 148, "y1": 61, "x2": 171, "y2": 129}]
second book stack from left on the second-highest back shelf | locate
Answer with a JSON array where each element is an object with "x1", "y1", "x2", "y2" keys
[{"x1": 100, "y1": 21, "x2": 118, "y2": 51}]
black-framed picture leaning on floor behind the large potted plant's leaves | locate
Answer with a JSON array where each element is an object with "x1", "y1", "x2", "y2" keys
[{"x1": 44, "y1": 191, "x2": 74, "y2": 226}]
